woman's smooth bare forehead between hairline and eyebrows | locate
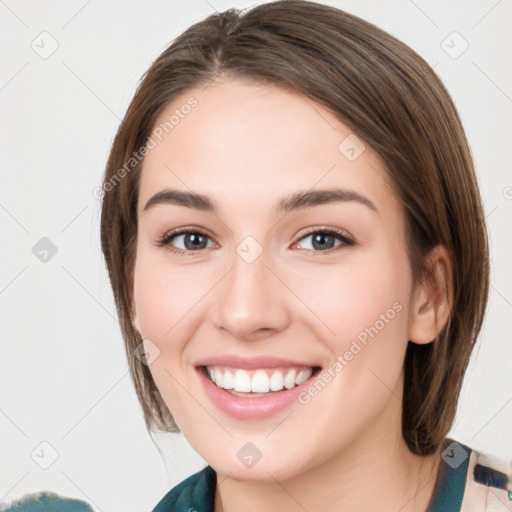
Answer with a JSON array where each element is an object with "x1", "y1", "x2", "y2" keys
[{"x1": 139, "y1": 80, "x2": 394, "y2": 213}]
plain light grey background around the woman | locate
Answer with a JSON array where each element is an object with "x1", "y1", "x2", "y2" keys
[{"x1": 0, "y1": 0, "x2": 512, "y2": 512}]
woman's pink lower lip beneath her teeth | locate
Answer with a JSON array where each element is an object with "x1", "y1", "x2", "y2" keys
[{"x1": 196, "y1": 368, "x2": 316, "y2": 420}]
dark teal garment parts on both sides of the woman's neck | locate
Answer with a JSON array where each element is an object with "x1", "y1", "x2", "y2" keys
[{"x1": 153, "y1": 440, "x2": 471, "y2": 512}]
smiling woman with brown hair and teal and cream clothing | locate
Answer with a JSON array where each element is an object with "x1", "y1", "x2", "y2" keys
[{"x1": 101, "y1": 0, "x2": 510, "y2": 512}]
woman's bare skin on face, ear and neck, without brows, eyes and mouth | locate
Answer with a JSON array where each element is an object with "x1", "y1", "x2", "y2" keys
[{"x1": 134, "y1": 79, "x2": 452, "y2": 512}]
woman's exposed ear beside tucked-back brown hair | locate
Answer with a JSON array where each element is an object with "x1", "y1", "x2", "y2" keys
[{"x1": 409, "y1": 245, "x2": 453, "y2": 344}]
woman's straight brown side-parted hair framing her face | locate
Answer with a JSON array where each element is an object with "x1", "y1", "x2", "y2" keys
[{"x1": 101, "y1": 0, "x2": 489, "y2": 455}]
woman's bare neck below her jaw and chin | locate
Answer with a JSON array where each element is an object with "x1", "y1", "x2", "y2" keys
[{"x1": 215, "y1": 400, "x2": 441, "y2": 512}]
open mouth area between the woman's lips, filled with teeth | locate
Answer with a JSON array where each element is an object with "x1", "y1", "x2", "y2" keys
[{"x1": 201, "y1": 365, "x2": 320, "y2": 398}]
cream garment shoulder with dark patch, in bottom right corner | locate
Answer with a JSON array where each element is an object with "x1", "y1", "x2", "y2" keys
[{"x1": 460, "y1": 442, "x2": 512, "y2": 512}]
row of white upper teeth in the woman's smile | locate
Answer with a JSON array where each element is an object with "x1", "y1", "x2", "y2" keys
[{"x1": 207, "y1": 367, "x2": 313, "y2": 393}]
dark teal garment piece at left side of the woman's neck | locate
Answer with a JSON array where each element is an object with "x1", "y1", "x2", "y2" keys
[{"x1": 153, "y1": 466, "x2": 217, "y2": 512}]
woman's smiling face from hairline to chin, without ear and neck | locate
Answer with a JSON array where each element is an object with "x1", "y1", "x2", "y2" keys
[{"x1": 134, "y1": 80, "x2": 420, "y2": 480}]
